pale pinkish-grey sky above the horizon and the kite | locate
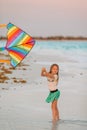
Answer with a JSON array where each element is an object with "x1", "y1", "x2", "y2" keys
[{"x1": 0, "y1": 0, "x2": 87, "y2": 37}]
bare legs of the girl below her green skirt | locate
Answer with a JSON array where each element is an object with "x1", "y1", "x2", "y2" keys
[{"x1": 51, "y1": 100, "x2": 59, "y2": 121}]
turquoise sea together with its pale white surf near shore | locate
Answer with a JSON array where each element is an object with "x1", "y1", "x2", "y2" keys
[{"x1": 0, "y1": 41, "x2": 87, "y2": 63}]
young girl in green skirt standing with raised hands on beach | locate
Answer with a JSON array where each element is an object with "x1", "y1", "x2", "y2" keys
[{"x1": 41, "y1": 64, "x2": 60, "y2": 121}]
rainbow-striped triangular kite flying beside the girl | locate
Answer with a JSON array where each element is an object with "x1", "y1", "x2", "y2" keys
[{"x1": 0, "y1": 23, "x2": 35, "y2": 67}]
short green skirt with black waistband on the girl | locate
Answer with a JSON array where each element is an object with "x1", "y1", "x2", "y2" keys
[{"x1": 46, "y1": 90, "x2": 60, "y2": 103}]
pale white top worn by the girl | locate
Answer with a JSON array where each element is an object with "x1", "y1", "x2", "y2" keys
[{"x1": 47, "y1": 74, "x2": 58, "y2": 91}]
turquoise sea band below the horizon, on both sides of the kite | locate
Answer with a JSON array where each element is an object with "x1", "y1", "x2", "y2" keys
[{"x1": 0, "y1": 40, "x2": 87, "y2": 54}]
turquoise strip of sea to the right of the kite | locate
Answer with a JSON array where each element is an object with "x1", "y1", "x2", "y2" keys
[{"x1": 36, "y1": 41, "x2": 87, "y2": 51}]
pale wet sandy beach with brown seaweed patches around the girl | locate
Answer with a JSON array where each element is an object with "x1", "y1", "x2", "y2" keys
[{"x1": 0, "y1": 40, "x2": 87, "y2": 130}]
